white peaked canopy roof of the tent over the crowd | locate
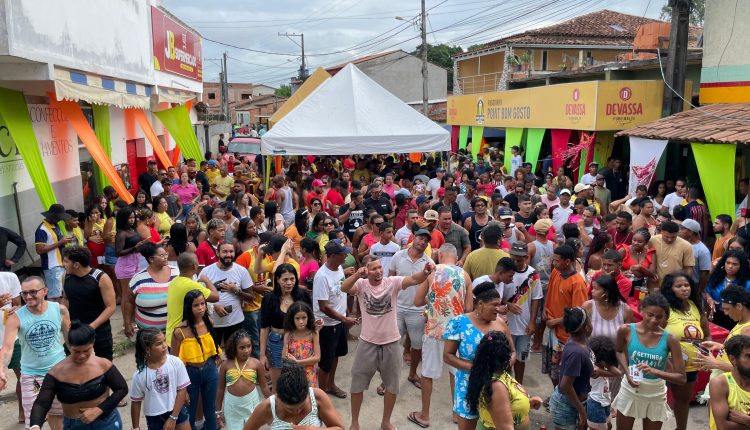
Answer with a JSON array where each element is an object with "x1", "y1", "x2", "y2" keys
[{"x1": 261, "y1": 64, "x2": 450, "y2": 155}]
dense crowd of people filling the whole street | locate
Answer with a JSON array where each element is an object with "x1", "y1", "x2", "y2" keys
[{"x1": 0, "y1": 147, "x2": 750, "y2": 430}]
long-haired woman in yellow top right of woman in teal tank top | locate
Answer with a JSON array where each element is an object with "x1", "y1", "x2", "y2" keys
[{"x1": 661, "y1": 272, "x2": 711, "y2": 430}]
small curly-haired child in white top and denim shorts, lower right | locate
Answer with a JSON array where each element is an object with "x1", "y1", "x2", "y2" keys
[{"x1": 586, "y1": 336, "x2": 622, "y2": 430}]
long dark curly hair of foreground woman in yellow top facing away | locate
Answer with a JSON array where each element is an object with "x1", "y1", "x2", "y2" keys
[{"x1": 466, "y1": 331, "x2": 511, "y2": 414}]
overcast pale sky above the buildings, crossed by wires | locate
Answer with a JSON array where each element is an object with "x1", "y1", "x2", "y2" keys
[{"x1": 163, "y1": 0, "x2": 666, "y2": 87}]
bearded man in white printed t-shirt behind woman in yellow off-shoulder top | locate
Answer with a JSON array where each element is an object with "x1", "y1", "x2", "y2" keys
[{"x1": 201, "y1": 242, "x2": 255, "y2": 345}]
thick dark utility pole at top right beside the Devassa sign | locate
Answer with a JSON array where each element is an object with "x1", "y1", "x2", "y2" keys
[{"x1": 662, "y1": 0, "x2": 693, "y2": 116}]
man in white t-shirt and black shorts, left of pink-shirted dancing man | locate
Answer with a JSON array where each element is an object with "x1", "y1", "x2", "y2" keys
[{"x1": 313, "y1": 240, "x2": 357, "y2": 399}]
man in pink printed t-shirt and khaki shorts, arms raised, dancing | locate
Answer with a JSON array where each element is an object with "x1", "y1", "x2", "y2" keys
[{"x1": 341, "y1": 255, "x2": 434, "y2": 429}]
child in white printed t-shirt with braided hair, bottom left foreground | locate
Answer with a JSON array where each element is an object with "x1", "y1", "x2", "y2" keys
[{"x1": 130, "y1": 328, "x2": 190, "y2": 430}]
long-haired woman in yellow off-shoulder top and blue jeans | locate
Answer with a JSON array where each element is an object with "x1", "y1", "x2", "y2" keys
[{"x1": 171, "y1": 290, "x2": 221, "y2": 430}]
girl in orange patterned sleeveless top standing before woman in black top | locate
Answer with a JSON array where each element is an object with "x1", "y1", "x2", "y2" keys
[{"x1": 281, "y1": 301, "x2": 320, "y2": 387}]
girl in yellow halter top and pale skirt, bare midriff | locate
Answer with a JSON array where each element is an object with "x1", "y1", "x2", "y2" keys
[{"x1": 216, "y1": 330, "x2": 271, "y2": 430}]
